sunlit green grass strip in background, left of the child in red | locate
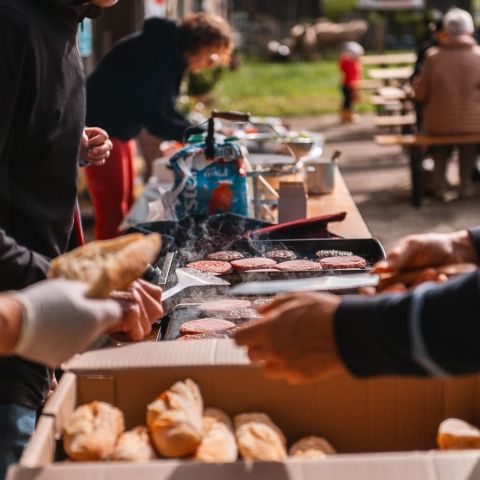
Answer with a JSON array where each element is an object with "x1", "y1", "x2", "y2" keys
[{"x1": 213, "y1": 60, "x2": 369, "y2": 116}]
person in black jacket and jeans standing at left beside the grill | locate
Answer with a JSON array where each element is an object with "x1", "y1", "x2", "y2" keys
[{"x1": 0, "y1": 0, "x2": 161, "y2": 479}]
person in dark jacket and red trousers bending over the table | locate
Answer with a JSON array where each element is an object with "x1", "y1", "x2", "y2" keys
[{"x1": 86, "y1": 13, "x2": 232, "y2": 239}]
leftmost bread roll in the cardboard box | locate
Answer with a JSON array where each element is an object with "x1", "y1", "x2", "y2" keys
[{"x1": 63, "y1": 402, "x2": 125, "y2": 461}]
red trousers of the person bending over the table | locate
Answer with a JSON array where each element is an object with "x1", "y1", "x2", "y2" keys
[{"x1": 85, "y1": 138, "x2": 136, "y2": 240}]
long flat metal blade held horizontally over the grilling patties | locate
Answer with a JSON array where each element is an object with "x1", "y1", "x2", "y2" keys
[{"x1": 231, "y1": 273, "x2": 379, "y2": 295}]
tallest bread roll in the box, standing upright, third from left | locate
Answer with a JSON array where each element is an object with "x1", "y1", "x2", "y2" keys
[{"x1": 147, "y1": 379, "x2": 203, "y2": 458}]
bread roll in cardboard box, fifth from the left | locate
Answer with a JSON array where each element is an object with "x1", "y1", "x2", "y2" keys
[{"x1": 235, "y1": 413, "x2": 287, "y2": 461}]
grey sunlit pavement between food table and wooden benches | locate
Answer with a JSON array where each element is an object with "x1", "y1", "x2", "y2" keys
[{"x1": 288, "y1": 115, "x2": 480, "y2": 249}]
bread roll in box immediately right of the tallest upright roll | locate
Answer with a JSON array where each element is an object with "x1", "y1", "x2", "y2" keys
[{"x1": 194, "y1": 408, "x2": 238, "y2": 463}]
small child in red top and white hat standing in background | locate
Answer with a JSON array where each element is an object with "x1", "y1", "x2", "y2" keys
[{"x1": 339, "y1": 42, "x2": 364, "y2": 123}]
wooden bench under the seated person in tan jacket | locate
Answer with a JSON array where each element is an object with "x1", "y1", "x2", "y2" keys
[{"x1": 375, "y1": 134, "x2": 480, "y2": 207}]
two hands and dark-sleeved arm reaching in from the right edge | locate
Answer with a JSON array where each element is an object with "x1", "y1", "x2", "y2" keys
[{"x1": 236, "y1": 228, "x2": 480, "y2": 382}]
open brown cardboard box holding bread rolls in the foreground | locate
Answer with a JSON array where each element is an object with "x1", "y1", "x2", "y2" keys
[{"x1": 7, "y1": 340, "x2": 480, "y2": 480}]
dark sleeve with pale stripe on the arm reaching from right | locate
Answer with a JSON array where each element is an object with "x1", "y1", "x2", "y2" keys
[{"x1": 334, "y1": 270, "x2": 480, "y2": 377}]
